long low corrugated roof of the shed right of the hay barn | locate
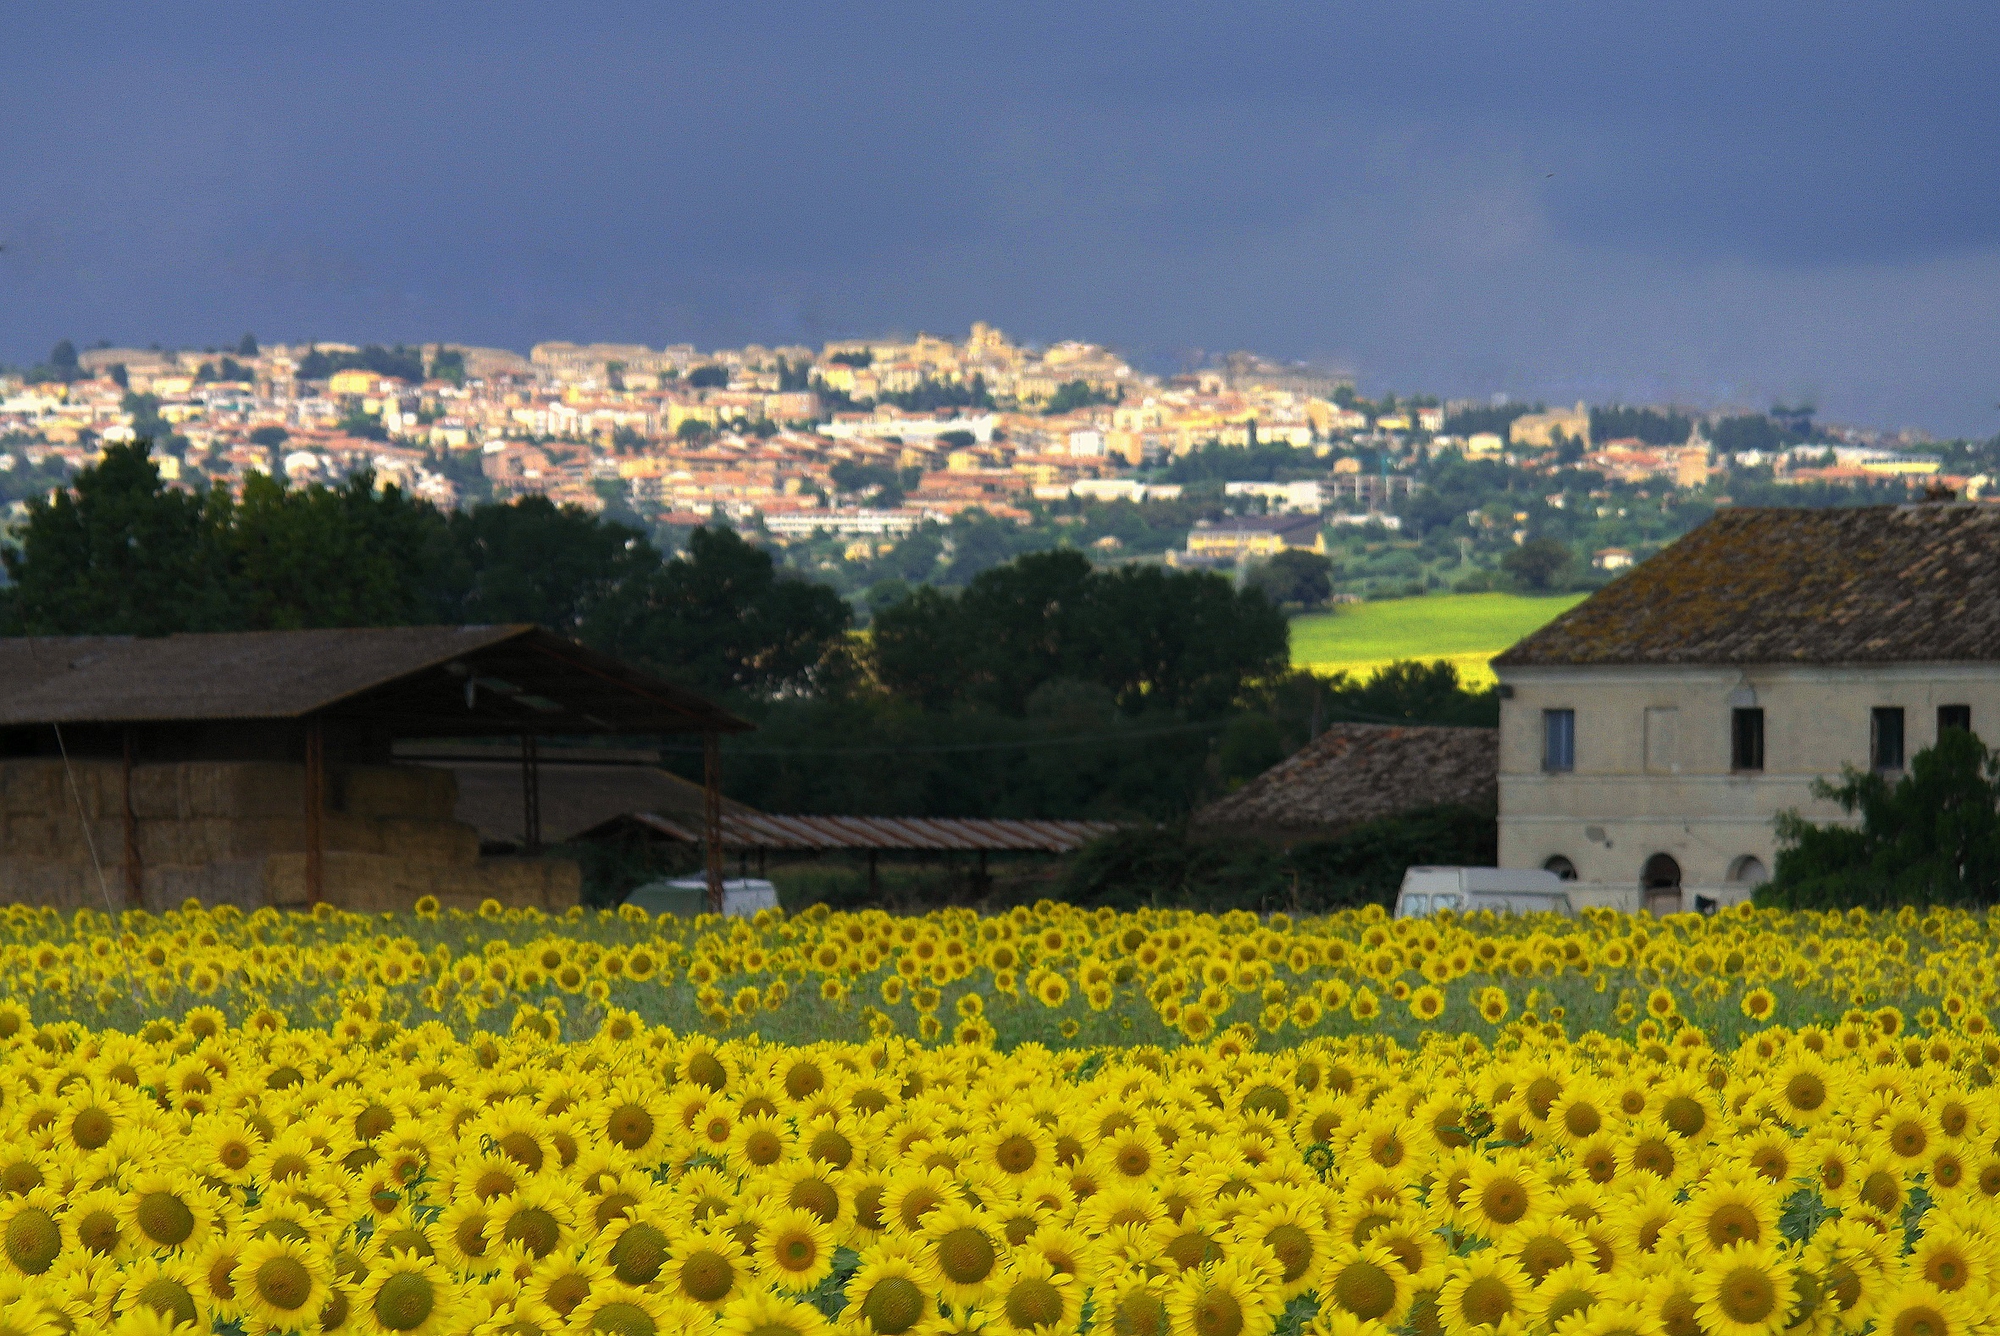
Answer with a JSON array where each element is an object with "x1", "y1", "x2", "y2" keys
[{"x1": 630, "y1": 812, "x2": 1116, "y2": 854}]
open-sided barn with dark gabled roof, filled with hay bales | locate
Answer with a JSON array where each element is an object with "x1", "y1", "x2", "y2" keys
[{"x1": 0, "y1": 626, "x2": 748, "y2": 910}]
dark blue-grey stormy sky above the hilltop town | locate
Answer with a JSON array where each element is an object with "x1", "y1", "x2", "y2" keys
[{"x1": 0, "y1": 0, "x2": 2000, "y2": 436}]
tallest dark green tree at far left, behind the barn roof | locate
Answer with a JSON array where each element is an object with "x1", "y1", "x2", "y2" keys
[{"x1": 0, "y1": 440, "x2": 234, "y2": 636}]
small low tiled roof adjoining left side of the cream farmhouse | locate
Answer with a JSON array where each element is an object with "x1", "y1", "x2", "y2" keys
[{"x1": 1194, "y1": 724, "x2": 1500, "y2": 836}]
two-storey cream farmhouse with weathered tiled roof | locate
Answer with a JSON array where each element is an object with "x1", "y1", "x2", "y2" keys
[{"x1": 1494, "y1": 504, "x2": 2000, "y2": 912}]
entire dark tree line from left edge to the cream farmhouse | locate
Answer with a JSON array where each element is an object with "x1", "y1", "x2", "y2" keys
[{"x1": 0, "y1": 442, "x2": 1498, "y2": 820}]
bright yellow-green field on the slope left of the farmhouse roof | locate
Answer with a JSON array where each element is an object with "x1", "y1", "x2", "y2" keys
[{"x1": 1292, "y1": 594, "x2": 1584, "y2": 686}]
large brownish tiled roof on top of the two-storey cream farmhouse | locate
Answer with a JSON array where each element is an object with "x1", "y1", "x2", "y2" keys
[{"x1": 1494, "y1": 504, "x2": 2000, "y2": 668}]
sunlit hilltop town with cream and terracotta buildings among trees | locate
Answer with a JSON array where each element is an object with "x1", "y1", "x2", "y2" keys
[{"x1": 0, "y1": 324, "x2": 1986, "y2": 596}]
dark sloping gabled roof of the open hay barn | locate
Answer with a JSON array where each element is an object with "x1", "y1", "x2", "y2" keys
[{"x1": 0, "y1": 626, "x2": 748, "y2": 738}]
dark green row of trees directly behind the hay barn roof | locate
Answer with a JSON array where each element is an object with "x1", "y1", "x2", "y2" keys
[{"x1": 0, "y1": 440, "x2": 848, "y2": 696}]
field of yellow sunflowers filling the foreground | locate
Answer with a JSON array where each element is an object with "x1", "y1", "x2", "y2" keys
[{"x1": 0, "y1": 904, "x2": 2000, "y2": 1336}]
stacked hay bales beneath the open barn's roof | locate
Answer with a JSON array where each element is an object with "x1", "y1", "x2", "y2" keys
[{"x1": 0, "y1": 760, "x2": 580, "y2": 910}]
